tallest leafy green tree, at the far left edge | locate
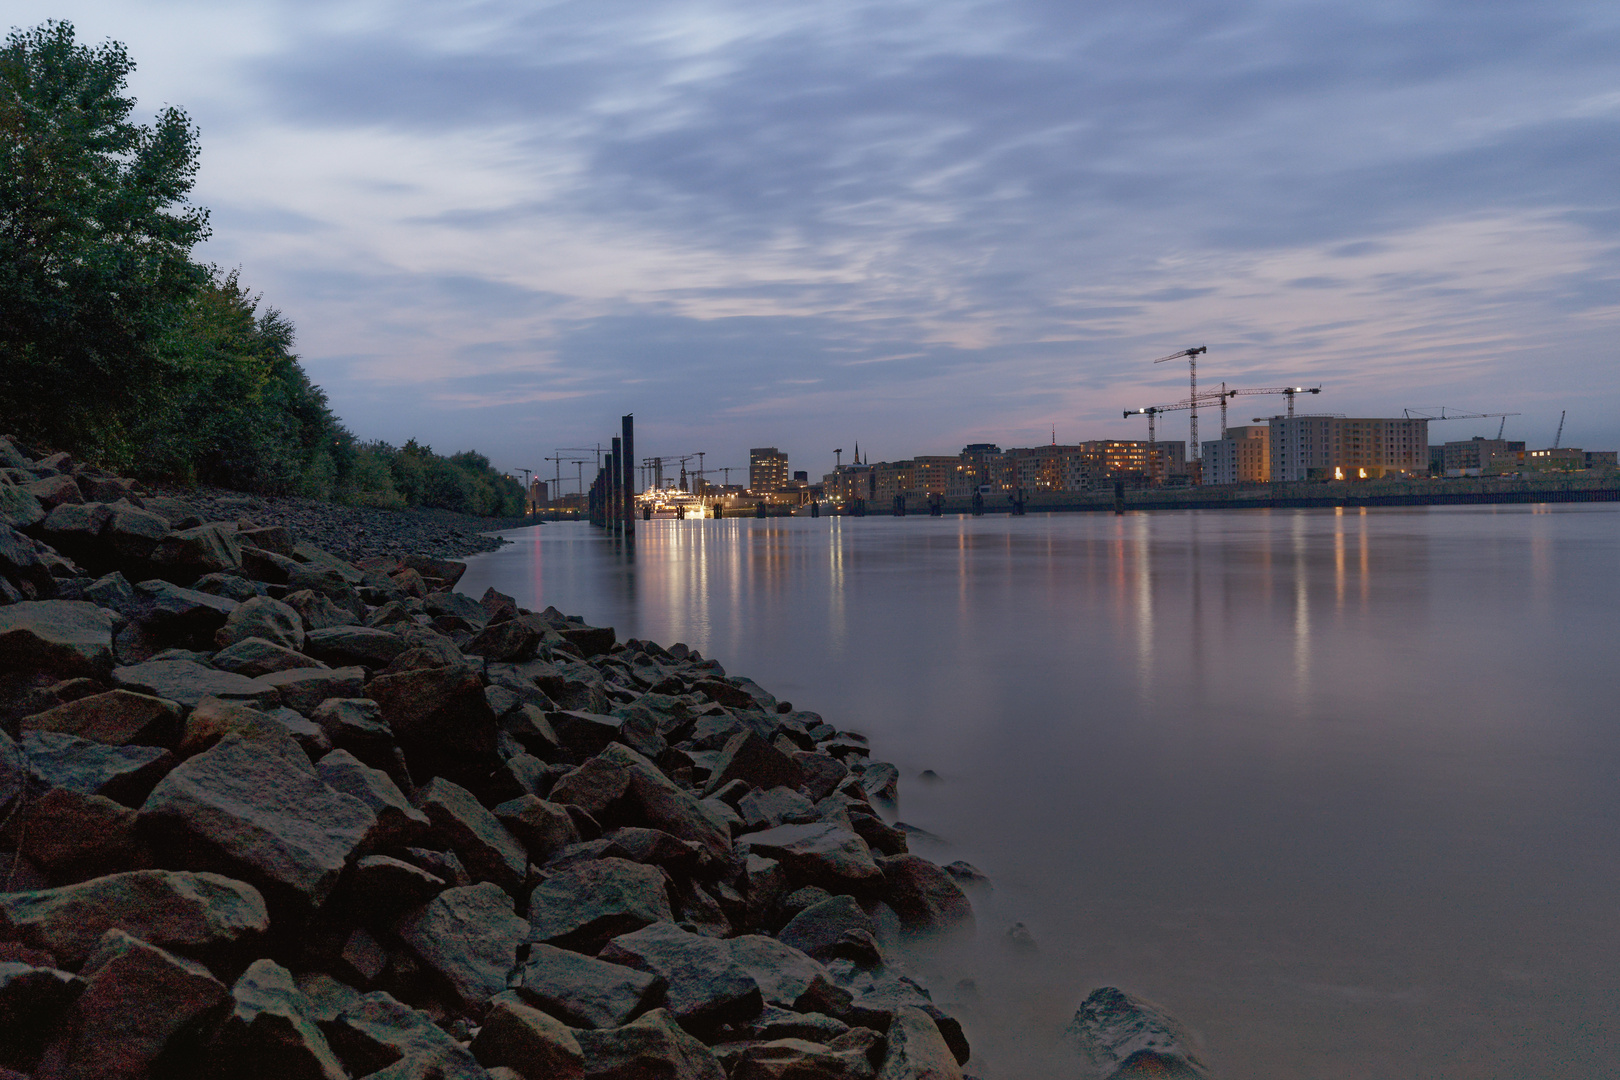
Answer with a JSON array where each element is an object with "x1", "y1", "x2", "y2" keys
[{"x1": 0, "y1": 21, "x2": 209, "y2": 461}]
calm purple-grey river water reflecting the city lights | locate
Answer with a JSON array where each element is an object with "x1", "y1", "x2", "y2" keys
[{"x1": 462, "y1": 505, "x2": 1620, "y2": 1080}]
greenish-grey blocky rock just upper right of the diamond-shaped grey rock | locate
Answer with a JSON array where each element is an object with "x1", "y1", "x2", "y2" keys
[{"x1": 528, "y1": 858, "x2": 676, "y2": 952}]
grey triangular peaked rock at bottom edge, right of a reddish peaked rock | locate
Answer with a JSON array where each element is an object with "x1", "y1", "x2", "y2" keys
[{"x1": 203, "y1": 960, "x2": 348, "y2": 1080}]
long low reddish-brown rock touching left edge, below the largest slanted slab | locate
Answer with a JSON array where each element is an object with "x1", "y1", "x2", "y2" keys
[{"x1": 0, "y1": 870, "x2": 271, "y2": 967}]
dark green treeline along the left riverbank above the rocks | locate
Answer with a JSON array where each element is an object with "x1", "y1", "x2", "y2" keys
[{"x1": 0, "y1": 21, "x2": 523, "y2": 517}]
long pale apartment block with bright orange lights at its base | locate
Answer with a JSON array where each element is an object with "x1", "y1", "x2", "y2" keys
[{"x1": 1270, "y1": 416, "x2": 1429, "y2": 483}]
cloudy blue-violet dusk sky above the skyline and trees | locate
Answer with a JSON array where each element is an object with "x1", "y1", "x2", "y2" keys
[{"x1": 6, "y1": 0, "x2": 1620, "y2": 476}]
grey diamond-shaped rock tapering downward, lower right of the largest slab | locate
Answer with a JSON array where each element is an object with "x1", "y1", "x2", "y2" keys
[{"x1": 397, "y1": 881, "x2": 528, "y2": 1007}]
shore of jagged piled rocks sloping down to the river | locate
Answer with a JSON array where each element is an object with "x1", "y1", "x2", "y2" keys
[{"x1": 0, "y1": 439, "x2": 1207, "y2": 1080}]
